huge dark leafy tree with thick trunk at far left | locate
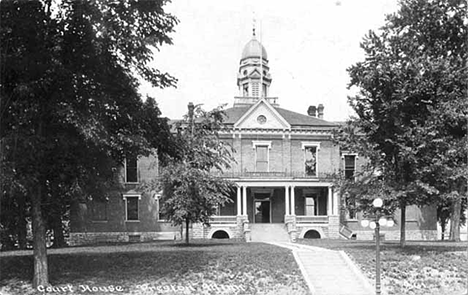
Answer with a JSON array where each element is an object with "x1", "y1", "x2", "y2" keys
[{"x1": 0, "y1": 0, "x2": 177, "y2": 288}]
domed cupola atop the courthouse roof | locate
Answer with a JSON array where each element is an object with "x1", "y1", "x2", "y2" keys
[{"x1": 237, "y1": 29, "x2": 271, "y2": 102}]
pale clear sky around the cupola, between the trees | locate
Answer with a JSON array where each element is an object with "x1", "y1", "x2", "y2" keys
[{"x1": 140, "y1": 0, "x2": 398, "y2": 121}]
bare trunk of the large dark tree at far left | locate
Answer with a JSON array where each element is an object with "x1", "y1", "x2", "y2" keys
[{"x1": 31, "y1": 184, "x2": 49, "y2": 289}]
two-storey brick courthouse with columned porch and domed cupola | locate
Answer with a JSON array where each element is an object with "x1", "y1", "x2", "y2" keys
[{"x1": 71, "y1": 34, "x2": 437, "y2": 244}]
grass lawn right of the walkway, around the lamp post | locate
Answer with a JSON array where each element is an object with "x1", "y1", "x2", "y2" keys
[{"x1": 300, "y1": 240, "x2": 468, "y2": 295}]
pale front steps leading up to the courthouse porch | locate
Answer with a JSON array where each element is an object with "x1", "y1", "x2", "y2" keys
[{"x1": 249, "y1": 223, "x2": 290, "y2": 242}]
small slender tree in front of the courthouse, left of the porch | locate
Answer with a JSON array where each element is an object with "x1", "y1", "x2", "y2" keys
[{"x1": 148, "y1": 105, "x2": 234, "y2": 244}]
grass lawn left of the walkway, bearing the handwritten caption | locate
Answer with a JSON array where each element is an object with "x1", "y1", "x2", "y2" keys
[{"x1": 0, "y1": 240, "x2": 309, "y2": 295}]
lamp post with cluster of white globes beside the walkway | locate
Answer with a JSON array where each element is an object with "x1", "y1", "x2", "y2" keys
[{"x1": 361, "y1": 198, "x2": 394, "y2": 295}]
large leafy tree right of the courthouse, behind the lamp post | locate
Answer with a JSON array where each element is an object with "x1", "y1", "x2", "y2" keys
[{"x1": 342, "y1": 0, "x2": 467, "y2": 246}]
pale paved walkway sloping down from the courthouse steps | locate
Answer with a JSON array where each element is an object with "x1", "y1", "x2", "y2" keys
[{"x1": 270, "y1": 243, "x2": 374, "y2": 295}]
